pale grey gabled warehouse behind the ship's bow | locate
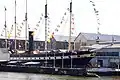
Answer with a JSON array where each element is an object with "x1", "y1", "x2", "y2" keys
[{"x1": 74, "y1": 33, "x2": 120, "y2": 50}]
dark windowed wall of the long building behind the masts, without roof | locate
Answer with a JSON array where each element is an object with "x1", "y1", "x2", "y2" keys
[{"x1": 0, "y1": 39, "x2": 73, "y2": 50}]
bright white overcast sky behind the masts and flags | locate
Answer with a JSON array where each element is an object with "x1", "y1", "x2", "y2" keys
[{"x1": 0, "y1": 0, "x2": 120, "y2": 40}]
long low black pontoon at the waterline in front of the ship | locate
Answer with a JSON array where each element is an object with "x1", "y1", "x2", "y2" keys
[{"x1": 0, "y1": 66, "x2": 87, "y2": 76}]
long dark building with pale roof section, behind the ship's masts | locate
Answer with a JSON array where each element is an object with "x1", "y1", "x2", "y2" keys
[{"x1": 0, "y1": 35, "x2": 75, "y2": 50}]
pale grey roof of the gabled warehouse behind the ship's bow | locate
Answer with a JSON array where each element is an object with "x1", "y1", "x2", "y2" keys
[{"x1": 76, "y1": 33, "x2": 120, "y2": 41}]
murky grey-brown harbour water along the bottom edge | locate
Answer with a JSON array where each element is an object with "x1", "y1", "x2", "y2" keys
[{"x1": 0, "y1": 72, "x2": 120, "y2": 80}]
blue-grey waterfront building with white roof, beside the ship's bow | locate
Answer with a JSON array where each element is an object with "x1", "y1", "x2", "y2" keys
[{"x1": 87, "y1": 42, "x2": 120, "y2": 68}]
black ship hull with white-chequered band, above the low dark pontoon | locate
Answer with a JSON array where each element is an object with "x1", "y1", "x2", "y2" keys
[{"x1": 10, "y1": 50, "x2": 94, "y2": 68}]
